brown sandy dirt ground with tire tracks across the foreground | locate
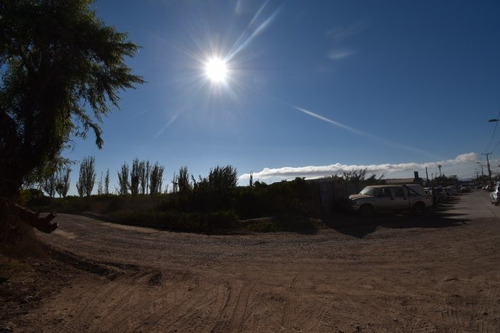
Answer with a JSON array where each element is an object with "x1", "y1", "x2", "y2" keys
[{"x1": 0, "y1": 191, "x2": 500, "y2": 332}]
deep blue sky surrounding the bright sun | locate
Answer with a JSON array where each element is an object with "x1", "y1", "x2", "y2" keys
[{"x1": 65, "y1": 0, "x2": 500, "y2": 192}]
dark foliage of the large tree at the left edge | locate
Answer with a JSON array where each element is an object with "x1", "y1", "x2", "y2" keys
[{"x1": 0, "y1": 0, "x2": 143, "y2": 198}]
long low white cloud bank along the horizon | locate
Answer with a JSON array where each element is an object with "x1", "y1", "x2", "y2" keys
[{"x1": 239, "y1": 153, "x2": 479, "y2": 183}]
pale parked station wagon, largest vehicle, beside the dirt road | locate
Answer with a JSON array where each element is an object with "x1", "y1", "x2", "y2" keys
[{"x1": 349, "y1": 184, "x2": 432, "y2": 216}]
